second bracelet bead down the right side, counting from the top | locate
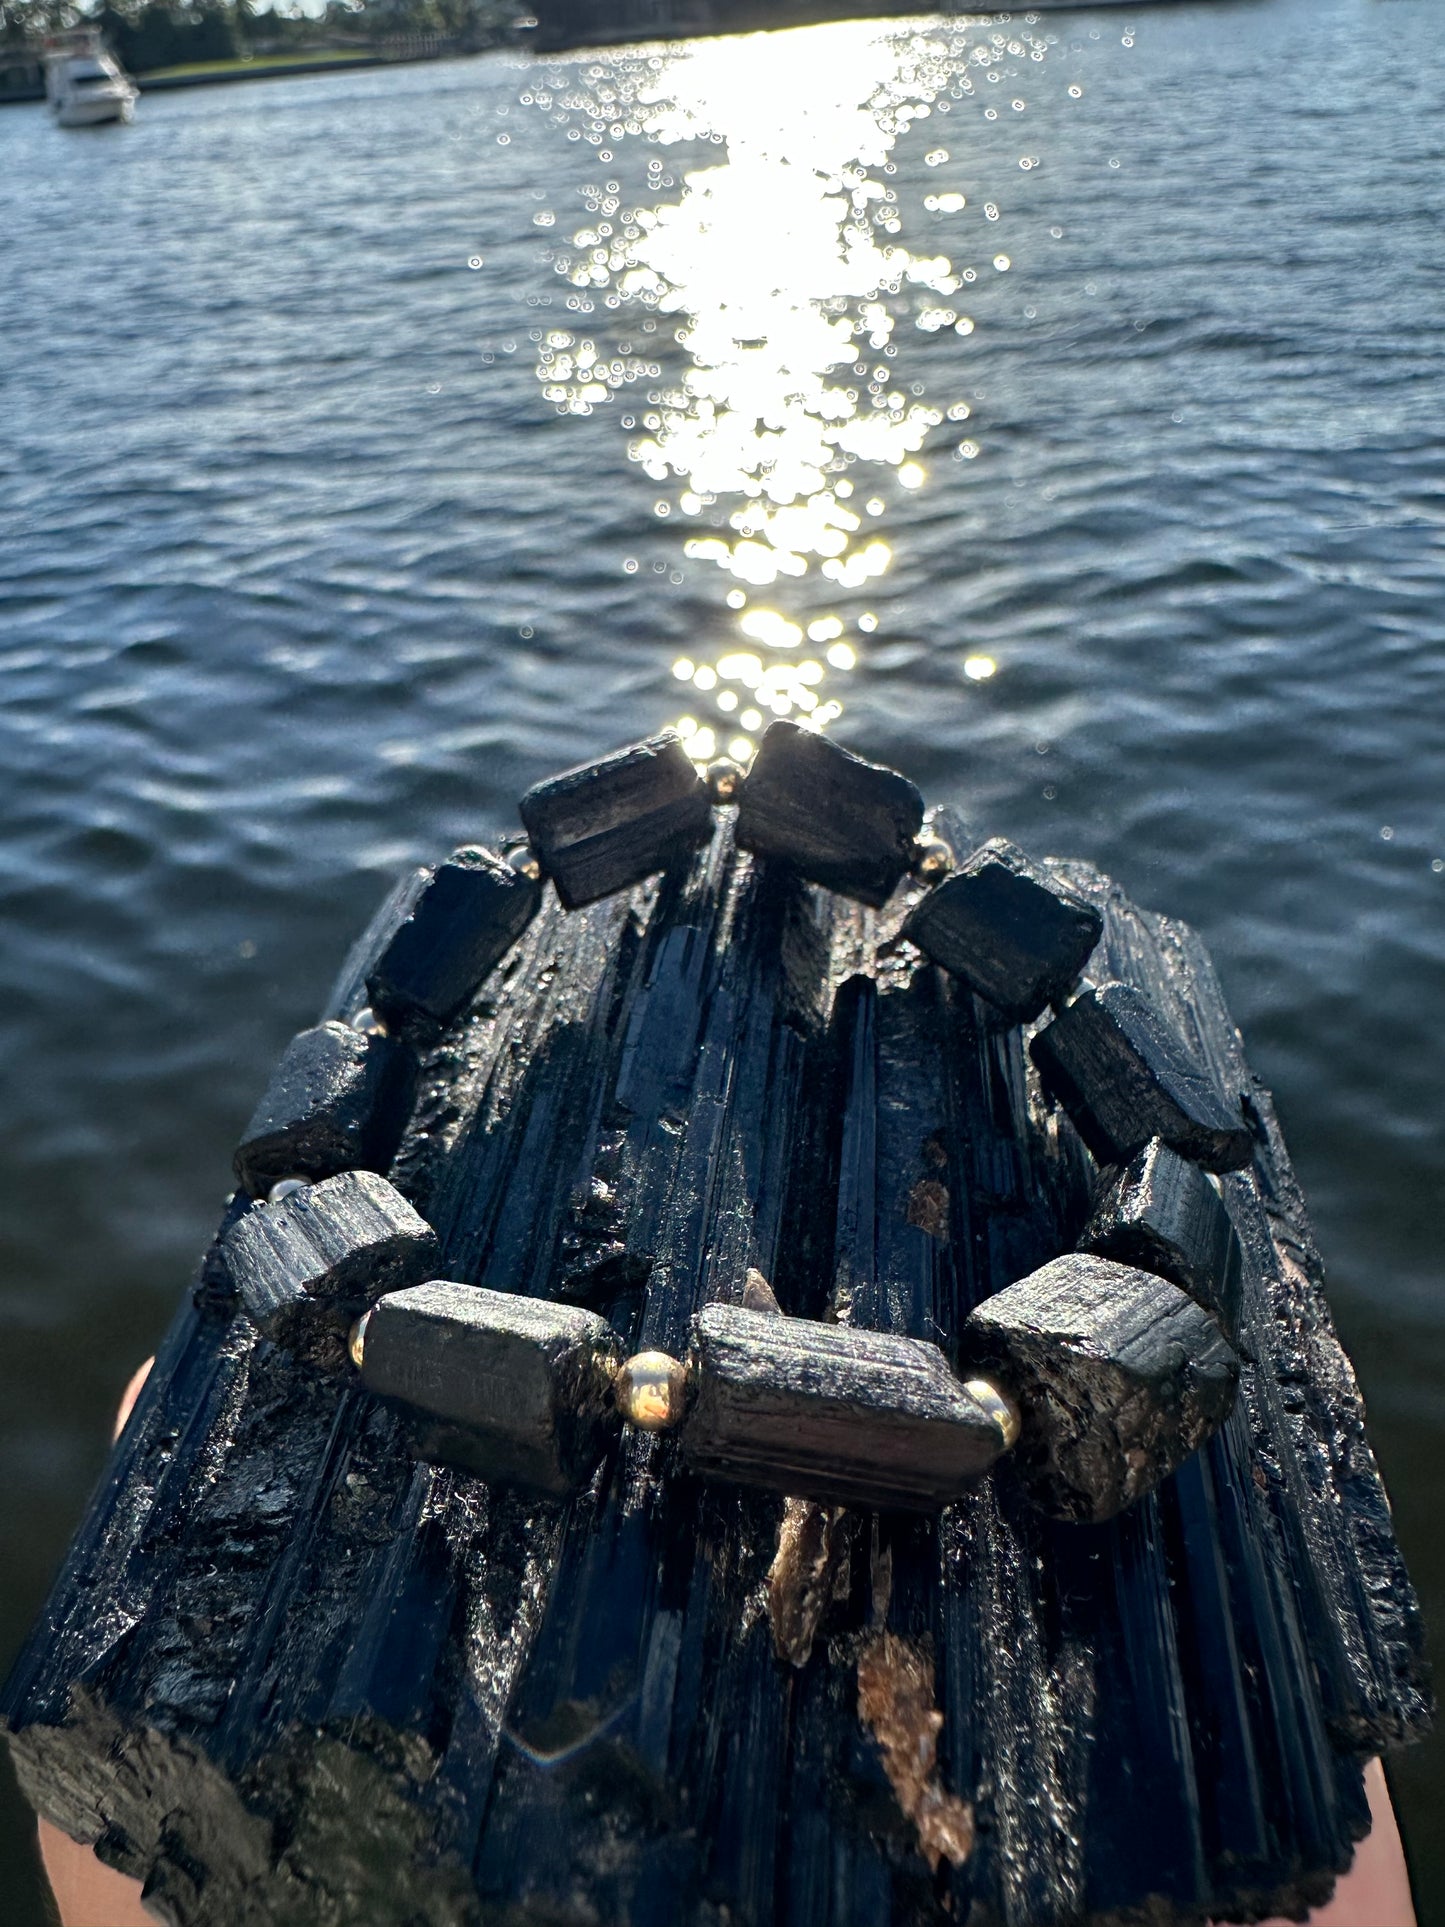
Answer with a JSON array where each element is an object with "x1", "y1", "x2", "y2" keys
[{"x1": 904, "y1": 836, "x2": 1104, "y2": 1023}]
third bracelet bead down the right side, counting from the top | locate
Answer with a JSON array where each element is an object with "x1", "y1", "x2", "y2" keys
[{"x1": 1029, "y1": 983, "x2": 1254, "y2": 1172}]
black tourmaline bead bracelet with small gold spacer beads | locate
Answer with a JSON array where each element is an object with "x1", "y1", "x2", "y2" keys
[{"x1": 220, "y1": 723, "x2": 1252, "y2": 1520}]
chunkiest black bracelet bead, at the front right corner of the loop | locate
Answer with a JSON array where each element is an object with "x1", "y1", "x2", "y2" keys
[{"x1": 963, "y1": 1251, "x2": 1239, "y2": 1520}]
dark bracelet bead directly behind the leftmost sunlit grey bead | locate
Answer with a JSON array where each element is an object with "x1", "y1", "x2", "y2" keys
[{"x1": 233, "y1": 1021, "x2": 416, "y2": 1199}]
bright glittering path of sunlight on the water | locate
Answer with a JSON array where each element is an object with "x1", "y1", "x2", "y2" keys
[{"x1": 522, "y1": 17, "x2": 1086, "y2": 761}]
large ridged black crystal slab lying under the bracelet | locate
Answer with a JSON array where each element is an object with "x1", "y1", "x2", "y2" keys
[{"x1": 0, "y1": 828, "x2": 1430, "y2": 1927}]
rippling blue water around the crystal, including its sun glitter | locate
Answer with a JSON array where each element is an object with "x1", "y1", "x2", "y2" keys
[{"x1": 0, "y1": 0, "x2": 1445, "y2": 1921}]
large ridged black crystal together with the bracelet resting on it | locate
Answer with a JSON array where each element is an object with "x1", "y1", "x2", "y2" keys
[{"x1": 11, "y1": 725, "x2": 1428, "y2": 1927}]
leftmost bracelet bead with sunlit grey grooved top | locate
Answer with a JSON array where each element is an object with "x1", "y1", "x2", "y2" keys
[{"x1": 218, "y1": 1172, "x2": 441, "y2": 1366}]
